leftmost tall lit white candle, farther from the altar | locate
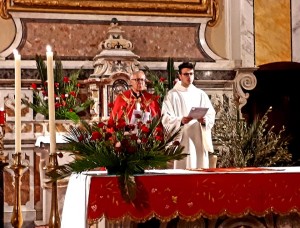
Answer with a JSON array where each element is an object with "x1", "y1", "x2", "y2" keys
[{"x1": 13, "y1": 50, "x2": 22, "y2": 153}]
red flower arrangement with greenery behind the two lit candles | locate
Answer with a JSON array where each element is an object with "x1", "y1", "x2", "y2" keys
[{"x1": 22, "y1": 55, "x2": 93, "y2": 122}]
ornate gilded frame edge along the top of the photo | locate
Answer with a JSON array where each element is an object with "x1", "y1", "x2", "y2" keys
[{"x1": 0, "y1": 0, "x2": 217, "y2": 19}]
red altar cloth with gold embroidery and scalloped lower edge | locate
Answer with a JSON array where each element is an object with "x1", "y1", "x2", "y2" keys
[{"x1": 87, "y1": 170, "x2": 300, "y2": 223}]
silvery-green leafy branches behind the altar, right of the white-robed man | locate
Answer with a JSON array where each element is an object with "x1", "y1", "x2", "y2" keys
[{"x1": 213, "y1": 97, "x2": 292, "y2": 167}]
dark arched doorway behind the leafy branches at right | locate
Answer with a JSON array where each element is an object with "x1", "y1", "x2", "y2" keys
[{"x1": 242, "y1": 62, "x2": 300, "y2": 165}]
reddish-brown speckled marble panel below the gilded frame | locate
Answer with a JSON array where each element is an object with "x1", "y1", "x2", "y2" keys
[{"x1": 20, "y1": 21, "x2": 205, "y2": 61}]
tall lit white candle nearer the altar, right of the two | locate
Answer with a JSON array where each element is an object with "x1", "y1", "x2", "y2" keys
[{"x1": 46, "y1": 45, "x2": 56, "y2": 154}]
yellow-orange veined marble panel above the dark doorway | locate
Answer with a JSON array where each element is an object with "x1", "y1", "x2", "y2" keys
[{"x1": 254, "y1": 0, "x2": 291, "y2": 66}]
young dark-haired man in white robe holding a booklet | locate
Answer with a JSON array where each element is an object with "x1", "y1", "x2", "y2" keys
[{"x1": 162, "y1": 62, "x2": 216, "y2": 169}]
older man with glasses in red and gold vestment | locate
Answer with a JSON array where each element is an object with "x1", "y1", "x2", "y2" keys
[{"x1": 110, "y1": 71, "x2": 161, "y2": 121}]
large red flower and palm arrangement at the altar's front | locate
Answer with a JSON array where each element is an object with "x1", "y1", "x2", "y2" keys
[{"x1": 47, "y1": 111, "x2": 186, "y2": 202}]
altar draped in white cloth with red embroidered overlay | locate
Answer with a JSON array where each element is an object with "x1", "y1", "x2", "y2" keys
[{"x1": 62, "y1": 167, "x2": 300, "y2": 228}]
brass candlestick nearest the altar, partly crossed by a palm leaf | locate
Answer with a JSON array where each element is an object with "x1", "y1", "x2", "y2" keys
[{"x1": 46, "y1": 152, "x2": 60, "y2": 228}]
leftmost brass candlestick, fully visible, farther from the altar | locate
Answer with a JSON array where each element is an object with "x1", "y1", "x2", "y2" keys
[{"x1": 8, "y1": 152, "x2": 28, "y2": 228}]
